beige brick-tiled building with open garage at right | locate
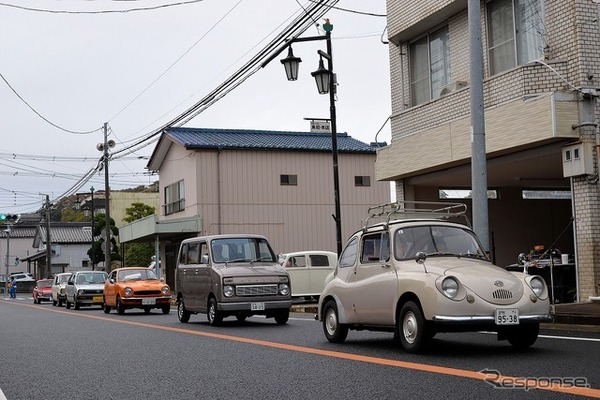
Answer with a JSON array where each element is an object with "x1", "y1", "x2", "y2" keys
[{"x1": 376, "y1": 0, "x2": 600, "y2": 300}]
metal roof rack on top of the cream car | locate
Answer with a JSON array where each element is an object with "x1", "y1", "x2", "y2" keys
[{"x1": 363, "y1": 201, "x2": 471, "y2": 229}]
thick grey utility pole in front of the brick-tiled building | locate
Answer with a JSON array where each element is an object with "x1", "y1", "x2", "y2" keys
[{"x1": 468, "y1": 0, "x2": 490, "y2": 251}]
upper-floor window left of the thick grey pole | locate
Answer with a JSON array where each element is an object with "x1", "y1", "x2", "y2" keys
[{"x1": 410, "y1": 26, "x2": 451, "y2": 105}]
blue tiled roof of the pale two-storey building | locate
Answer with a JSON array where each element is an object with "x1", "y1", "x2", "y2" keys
[{"x1": 165, "y1": 128, "x2": 376, "y2": 154}]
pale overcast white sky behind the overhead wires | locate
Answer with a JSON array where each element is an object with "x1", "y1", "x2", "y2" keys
[{"x1": 0, "y1": 0, "x2": 391, "y2": 213}]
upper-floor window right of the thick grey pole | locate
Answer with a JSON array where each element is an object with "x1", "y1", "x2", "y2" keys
[{"x1": 486, "y1": 0, "x2": 546, "y2": 75}]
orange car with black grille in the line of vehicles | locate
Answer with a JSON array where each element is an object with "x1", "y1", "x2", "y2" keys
[{"x1": 104, "y1": 267, "x2": 171, "y2": 314}]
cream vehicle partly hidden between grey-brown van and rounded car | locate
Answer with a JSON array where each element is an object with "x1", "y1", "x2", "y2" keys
[{"x1": 279, "y1": 251, "x2": 337, "y2": 299}]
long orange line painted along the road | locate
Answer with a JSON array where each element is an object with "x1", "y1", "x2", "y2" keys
[{"x1": 8, "y1": 304, "x2": 600, "y2": 399}]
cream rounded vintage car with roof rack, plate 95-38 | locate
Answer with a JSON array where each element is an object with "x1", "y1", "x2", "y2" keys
[{"x1": 316, "y1": 202, "x2": 552, "y2": 352}]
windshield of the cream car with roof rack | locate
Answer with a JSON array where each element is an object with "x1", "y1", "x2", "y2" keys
[{"x1": 394, "y1": 225, "x2": 487, "y2": 260}]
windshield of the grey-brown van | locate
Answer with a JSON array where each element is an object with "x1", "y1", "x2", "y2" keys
[{"x1": 211, "y1": 238, "x2": 277, "y2": 263}]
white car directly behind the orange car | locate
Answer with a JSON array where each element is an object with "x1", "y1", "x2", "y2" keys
[{"x1": 65, "y1": 271, "x2": 108, "y2": 310}]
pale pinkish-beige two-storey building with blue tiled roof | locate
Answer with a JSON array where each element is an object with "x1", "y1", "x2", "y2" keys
[{"x1": 119, "y1": 128, "x2": 390, "y2": 282}]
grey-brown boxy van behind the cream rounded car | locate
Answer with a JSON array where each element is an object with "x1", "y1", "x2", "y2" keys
[{"x1": 175, "y1": 234, "x2": 292, "y2": 325}]
